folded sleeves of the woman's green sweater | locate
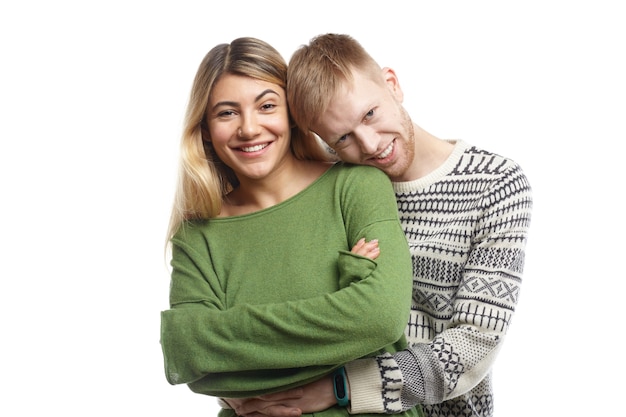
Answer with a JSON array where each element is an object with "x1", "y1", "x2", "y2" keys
[{"x1": 161, "y1": 169, "x2": 412, "y2": 397}]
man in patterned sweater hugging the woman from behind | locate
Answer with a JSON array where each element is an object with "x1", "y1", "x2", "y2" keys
[{"x1": 227, "y1": 34, "x2": 532, "y2": 417}]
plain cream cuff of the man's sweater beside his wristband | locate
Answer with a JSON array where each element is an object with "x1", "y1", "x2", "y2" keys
[{"x1": 345, "y1": 358, "x2": 385, "y2": 414}]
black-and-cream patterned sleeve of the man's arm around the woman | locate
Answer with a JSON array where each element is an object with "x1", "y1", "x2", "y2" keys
[{"x1": 346, "y1": 161, "x2": 532, "y2": 414}]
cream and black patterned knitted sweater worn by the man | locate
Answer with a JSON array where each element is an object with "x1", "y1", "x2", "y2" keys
[{"x1": 346, "y1": 141, "x2": 532, "y2": 417}]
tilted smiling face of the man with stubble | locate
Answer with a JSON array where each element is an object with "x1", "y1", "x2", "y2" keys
[{"x1": 311, "y1": 68, "x2": 415, "y2": 181}]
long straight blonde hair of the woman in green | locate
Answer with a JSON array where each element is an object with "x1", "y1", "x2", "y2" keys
[{"x1": 167, "y1": 37, "x2": 326, "y2": 242}]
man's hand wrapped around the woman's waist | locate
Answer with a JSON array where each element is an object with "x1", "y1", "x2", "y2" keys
[{"x1": 224, "y1": 376, "x2": 337, "y2": 417}]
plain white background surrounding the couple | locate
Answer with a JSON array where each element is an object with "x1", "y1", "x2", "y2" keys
[{"x1": 0, "y1": 0, "x2": 626, "y2": 417}]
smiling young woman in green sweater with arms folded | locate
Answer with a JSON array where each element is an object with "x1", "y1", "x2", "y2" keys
[{"x1": 161, "y1": 38, "x2": 417, "y2": 416}]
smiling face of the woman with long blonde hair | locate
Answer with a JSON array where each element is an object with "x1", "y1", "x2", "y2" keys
[{"x1": 207, "y1": 74, "x2": 291, "y2": 181}]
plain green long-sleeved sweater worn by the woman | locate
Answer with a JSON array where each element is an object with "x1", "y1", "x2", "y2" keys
[{"x1": 161, "y1": 163, "x2": 415, "y2": 415}]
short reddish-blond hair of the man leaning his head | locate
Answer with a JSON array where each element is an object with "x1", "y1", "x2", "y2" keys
[{"x1": 287, "y1": 33, "x2": 381, "y2": 132}]
